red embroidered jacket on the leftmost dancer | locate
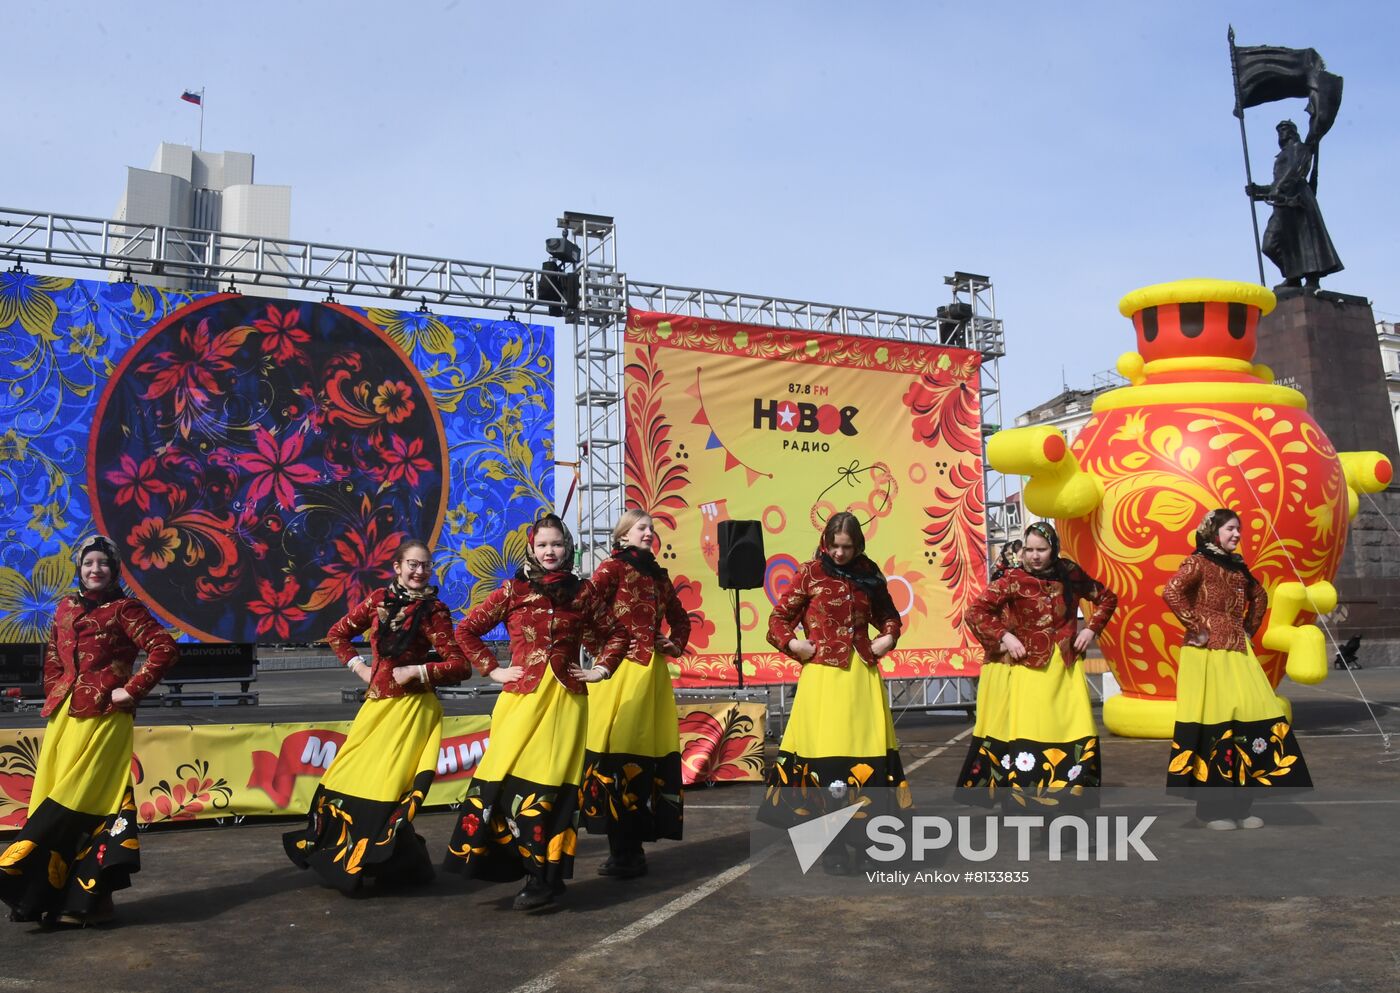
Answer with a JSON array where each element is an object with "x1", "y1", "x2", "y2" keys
[{"x1": 41, "y1": 594, "x2": 179, "y2": 717}]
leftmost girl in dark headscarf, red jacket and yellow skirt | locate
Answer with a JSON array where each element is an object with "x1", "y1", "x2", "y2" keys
[{"x1": 0, "y1": 535, "x2": 178, "y2": 924}]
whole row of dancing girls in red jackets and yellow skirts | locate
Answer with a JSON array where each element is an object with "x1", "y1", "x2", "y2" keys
[{"x1": 0, "y1": 510, "x2": 1310, "y2": 926}]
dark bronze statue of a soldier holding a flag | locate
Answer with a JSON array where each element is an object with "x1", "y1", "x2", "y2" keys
[{"x1": 1229, "y1": 28, "x2": 1343, "y2": 290}]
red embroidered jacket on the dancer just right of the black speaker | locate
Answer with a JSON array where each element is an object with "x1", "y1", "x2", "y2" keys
[{"x1": 769, "y1": 559, "x2": 903, "y2": 669}]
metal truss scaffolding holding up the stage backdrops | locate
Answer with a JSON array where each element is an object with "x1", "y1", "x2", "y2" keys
[{"x1": 0, "y1": 207, "x2": 1019, "y2": 596}]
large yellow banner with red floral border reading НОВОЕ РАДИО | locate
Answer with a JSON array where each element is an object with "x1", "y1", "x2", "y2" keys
[{"x1": 624, "y1": 311, "x2": 987, "y2": 685}]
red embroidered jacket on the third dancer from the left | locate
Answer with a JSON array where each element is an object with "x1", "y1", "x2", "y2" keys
[{"x1": 456, "y1": 580, "x2": 627, "y2": 693}]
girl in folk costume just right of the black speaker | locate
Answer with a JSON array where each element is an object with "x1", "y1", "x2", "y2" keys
[{"x1": 759, "y1": 511, "x2": 913, "y2": 874}]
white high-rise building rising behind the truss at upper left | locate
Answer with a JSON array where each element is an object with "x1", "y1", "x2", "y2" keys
[{"x1": 113, "y1": 141, "x2": 291, "y2": 289}]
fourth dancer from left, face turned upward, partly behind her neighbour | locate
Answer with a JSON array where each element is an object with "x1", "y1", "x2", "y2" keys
[{"x1": 582, "y1": 510, "x2": 690, "y2": 878}]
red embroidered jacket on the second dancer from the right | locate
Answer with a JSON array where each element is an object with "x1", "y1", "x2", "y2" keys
[{"x1": 963, "y1": 560, "x2": 1119, "y2": 669}]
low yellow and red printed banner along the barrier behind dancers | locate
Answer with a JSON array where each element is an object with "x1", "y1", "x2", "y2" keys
[{"x1": 0, "y1": 703, "x2": 766, "y2": 832}]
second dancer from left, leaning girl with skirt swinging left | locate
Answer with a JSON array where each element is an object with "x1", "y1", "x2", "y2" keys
[{"x1": 283, "y1": 541, "x2": 470, "y2": 894}]
